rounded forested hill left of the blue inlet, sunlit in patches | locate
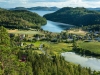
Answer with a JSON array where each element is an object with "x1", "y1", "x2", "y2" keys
[{"x1": 0, "y1": 8, "x2": 46, "y2": 28}]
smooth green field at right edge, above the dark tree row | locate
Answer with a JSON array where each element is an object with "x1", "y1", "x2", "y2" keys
[{"x1": 77, "y1": 41, "x2": 100, "y2": 54}]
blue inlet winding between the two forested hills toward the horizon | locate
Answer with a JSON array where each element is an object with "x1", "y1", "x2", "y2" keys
[{"x1": 32, "y1": 11, "x2": 73, "y2": 32}]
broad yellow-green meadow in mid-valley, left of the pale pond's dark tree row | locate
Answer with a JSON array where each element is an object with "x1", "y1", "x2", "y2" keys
[{"x1": 42, "y1": 43, "x2": 72, "y2": 55}]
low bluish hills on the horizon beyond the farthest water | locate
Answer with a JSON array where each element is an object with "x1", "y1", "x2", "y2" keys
[{"x1": 27, "y1": 6, "x2": 59, "y2": 11}]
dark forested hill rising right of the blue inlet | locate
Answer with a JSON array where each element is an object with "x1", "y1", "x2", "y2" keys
[{"x1": 44, "y1": 7, "x2": 100, "y2": 26}]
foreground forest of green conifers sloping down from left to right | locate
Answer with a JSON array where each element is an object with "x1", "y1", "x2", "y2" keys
[{"x1": 0, "y1": 27, "x2": 98, "y2": 75}]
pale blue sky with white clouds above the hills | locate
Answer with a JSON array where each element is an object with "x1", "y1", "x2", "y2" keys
[{"x1": 0, "y1": 0, "x2": 100, "y2": 8}]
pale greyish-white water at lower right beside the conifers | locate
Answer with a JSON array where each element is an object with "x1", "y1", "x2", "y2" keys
[{"x1": 61, "y1": 52, "x2": 100, "y2": 71}]
